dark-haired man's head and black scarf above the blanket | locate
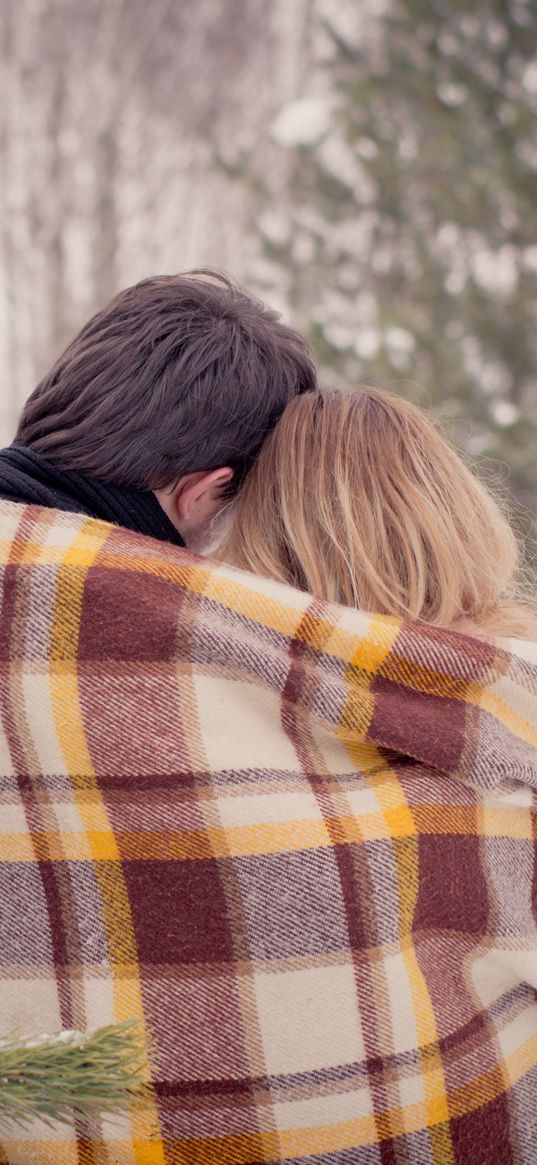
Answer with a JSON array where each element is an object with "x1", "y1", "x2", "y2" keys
[{"x1": 0, "y1": 271, "x2": 316, "y2": 548}]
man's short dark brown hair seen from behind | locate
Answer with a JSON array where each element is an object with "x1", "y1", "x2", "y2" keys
[{"x1": 17, "y1": 270, "x2": 316, "y2": 489}]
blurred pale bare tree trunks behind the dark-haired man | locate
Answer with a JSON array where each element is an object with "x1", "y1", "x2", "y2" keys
[{"x1": 0, "y1": 0, "x2": 313, "y2": 444}]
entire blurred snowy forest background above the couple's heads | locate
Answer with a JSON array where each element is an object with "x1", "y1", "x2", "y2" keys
[{"x1": 0, "y1": 0, "x2": 537, "y2": 532}]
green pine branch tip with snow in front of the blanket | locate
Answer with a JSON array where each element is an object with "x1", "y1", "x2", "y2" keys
[{"x1": 0, "y1": 1021, "x2": 146, "y2": 1128}]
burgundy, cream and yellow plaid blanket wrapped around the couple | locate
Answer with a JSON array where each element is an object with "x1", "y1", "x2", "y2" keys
[{"x1": 0, "y1": 502, "x2": 537, "y2": 1165}]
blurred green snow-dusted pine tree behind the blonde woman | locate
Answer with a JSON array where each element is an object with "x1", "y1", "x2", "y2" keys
[{"x1": 252, "y1": 0, "x2": 537, "y2": 519}]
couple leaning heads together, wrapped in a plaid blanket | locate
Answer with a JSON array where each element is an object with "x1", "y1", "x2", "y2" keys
[{"x1": 0, "y1": 273, "x2": 537, "y2": 1165}]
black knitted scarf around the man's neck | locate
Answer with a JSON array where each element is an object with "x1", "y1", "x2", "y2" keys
[{"x1": 0, "y1": 440, "x2": 184, "y2": 546}]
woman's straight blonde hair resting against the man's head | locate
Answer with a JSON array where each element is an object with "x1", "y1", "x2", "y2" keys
[{"x1": 219, "y1": 388, "x2": 537, "y2": 638}]
